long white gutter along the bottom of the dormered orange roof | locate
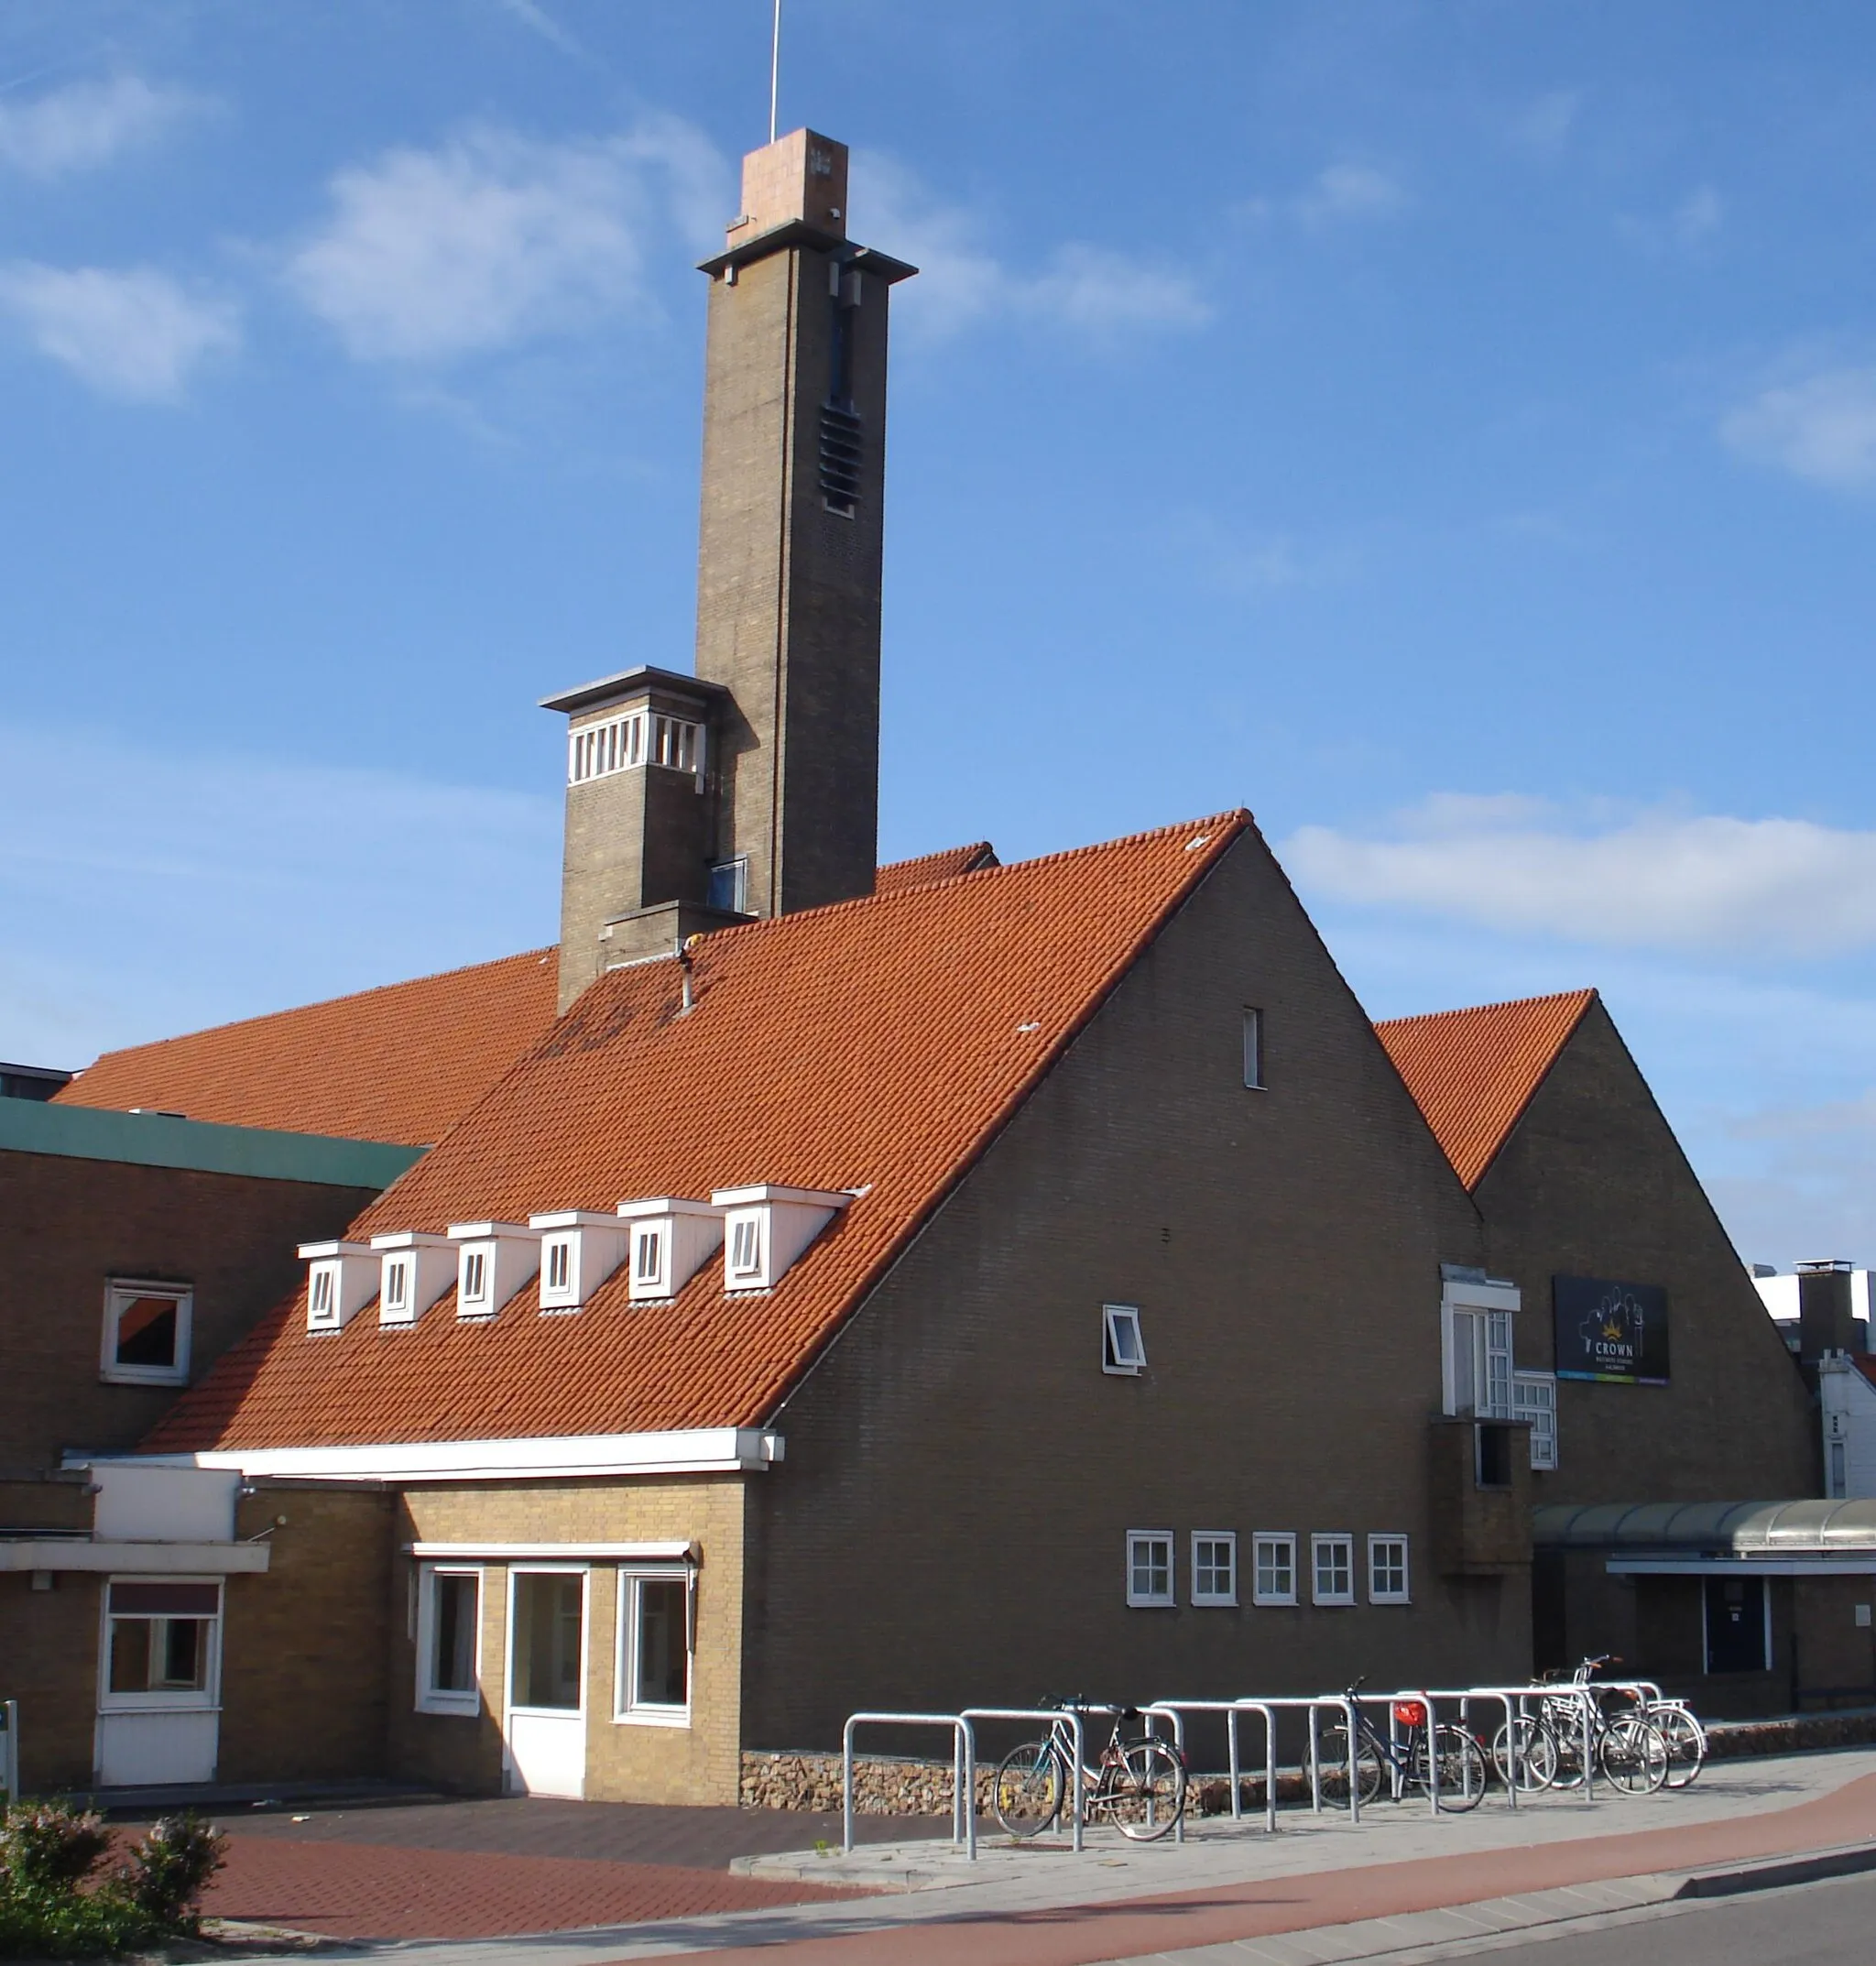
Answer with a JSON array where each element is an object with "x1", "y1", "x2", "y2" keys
[{"x1": 86, "y1": 1427, "x2": 785, "y2": 1482}]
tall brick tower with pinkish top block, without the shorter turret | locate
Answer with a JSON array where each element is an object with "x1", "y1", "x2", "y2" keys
[{"x1": 696, "y1": 130, "x2": 912, "y2": 914}]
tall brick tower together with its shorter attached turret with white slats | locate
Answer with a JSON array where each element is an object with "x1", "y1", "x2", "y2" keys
[{"x1": 545, "y1": 130, "x2": 916, "y2": 1010}]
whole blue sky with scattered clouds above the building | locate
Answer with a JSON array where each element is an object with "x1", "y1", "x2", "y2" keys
[{"x1": 0, "y1": 0, "x2": 1876, "y2": 1264}]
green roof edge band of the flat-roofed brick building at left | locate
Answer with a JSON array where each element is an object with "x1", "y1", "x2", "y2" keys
[{"x1": 0, "y1": 1099, "x2": 425, "y2": 1189}]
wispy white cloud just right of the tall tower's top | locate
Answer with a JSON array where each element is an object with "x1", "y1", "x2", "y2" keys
[{"x1": 849, "y1": 151, "x2": 1214, "y2": 344}]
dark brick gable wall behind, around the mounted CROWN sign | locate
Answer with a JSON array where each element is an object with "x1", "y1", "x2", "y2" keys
[{"x1": 1475, "y1": 1005, "x2": 1819, "y2": 1510}]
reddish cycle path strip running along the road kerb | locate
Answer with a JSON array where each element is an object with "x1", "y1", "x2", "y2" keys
[{"x1": 621, "y1": 1775, "x2": 1876, "y2": 1966}]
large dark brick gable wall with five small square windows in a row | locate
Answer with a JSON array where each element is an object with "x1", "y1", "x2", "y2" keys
[{"x1": 743, "y1": 837, "x2": 1502, "y2": 1748}]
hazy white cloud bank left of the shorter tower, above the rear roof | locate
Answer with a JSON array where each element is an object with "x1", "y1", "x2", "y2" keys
[{"x1": 0, "y1": 727, "x2": 561, "y2": 1065}]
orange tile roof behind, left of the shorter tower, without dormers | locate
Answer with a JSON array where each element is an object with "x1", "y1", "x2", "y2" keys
[{"x1": 59, "y1": 950, "x2": 557, "y2": 1146}]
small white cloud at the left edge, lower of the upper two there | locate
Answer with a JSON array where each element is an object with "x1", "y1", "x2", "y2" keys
[{"x1": 0, "y1": 259, "x2": 240, "y2": 403}]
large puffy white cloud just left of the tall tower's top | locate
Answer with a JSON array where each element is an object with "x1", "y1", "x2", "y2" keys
[{"x1": 285, "y1": 118, "x2": 734, "y2": 364}]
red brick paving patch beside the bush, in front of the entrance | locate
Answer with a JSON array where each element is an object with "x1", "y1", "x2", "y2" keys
[{"x1": 202, "y1": 1834, "x2": 867, "y2": 1939}]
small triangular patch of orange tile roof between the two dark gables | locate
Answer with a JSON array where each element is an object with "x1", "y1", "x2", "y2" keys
[{"x1": 1375, "y1": 988, "x2": 1597, "y2": 1187}]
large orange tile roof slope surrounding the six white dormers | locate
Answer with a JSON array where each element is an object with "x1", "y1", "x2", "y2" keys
[{"x1": 146, "y1": 814, "x2": 1249, "y2": 1451}]
